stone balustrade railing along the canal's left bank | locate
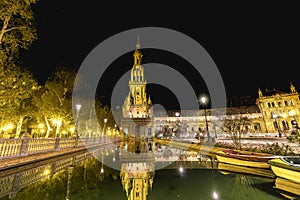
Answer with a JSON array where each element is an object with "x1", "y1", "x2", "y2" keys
[{"x1": 0, "y1": 135, "x2": 120, "y2": 160}]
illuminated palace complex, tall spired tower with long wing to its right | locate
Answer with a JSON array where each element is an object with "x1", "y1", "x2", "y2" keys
[{"x1": 122, "y1": 39, "x2": 300, "y2": 138}]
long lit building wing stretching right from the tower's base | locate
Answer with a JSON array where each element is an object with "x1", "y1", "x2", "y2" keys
[{"x1": 153, "y1": 84, "x2": 300, "y2": 136}]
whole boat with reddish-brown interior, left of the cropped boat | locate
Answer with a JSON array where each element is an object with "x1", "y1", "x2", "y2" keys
[{"x1": 216, "y1": 149, "x2": 279, "y2": 169}]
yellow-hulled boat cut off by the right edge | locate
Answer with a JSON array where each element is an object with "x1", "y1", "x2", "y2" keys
[{"x1": 269, "y1": 156, "x2": 300, "y2": 183}]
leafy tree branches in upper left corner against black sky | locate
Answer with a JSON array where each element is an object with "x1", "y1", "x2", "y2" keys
[{"x1": 0, "y1": 0, "x2": 37, "y2": 65}]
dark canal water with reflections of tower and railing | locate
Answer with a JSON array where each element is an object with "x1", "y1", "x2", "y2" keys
[{"x1": 0, "y1": 143, "x2": 300, "y2": 200}]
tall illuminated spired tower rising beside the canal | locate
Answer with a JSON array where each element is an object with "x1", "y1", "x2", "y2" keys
[{"x1": 122, "y1": 38, "x2": 153, "y2": 139}]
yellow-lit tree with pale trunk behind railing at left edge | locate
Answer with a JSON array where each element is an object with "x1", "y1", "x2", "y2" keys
[{"x1": 0, "y1": 65, "x2": 38, "y2": 137}]
